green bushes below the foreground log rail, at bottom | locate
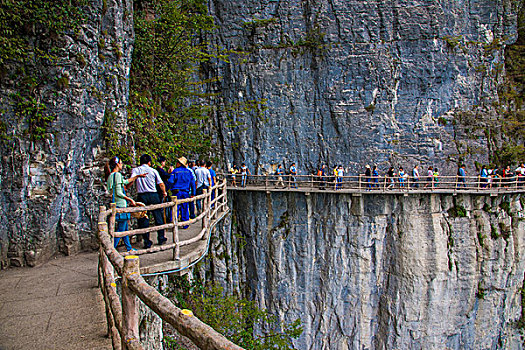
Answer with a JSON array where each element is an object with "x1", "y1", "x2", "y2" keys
[{"x1": 171, "y1": 277, "x2": 303, "y2": 350}]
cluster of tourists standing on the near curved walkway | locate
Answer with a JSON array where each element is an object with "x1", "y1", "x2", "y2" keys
[{"x1": 104, "y1": 154, "x2": 217, "y2": 251}]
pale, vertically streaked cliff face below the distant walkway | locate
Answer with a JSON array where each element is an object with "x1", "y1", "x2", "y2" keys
[{"x1": 208, "y1": 192, "x2": 525, "y2": 349}]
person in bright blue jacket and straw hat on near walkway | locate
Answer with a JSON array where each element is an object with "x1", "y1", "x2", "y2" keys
[{"x1": 167, "y1": 157, "x2": 195, "y2": 229}]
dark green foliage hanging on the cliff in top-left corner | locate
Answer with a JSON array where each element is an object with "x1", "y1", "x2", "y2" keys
[{"x1": 0, "y1": 0, "x2": 87, "y2": 140}]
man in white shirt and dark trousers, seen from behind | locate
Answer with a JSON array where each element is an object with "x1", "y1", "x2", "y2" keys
[{"x1": 131, "y1": 154, "x2": 167, "y2": 249}]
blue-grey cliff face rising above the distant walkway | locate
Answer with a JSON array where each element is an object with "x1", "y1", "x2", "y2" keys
[{"x1": 210, "y1": 0, "x2": 519, "y2": 173}]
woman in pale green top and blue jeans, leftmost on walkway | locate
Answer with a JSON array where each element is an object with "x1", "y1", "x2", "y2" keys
[{"x1": 104, "y1": 157, "x2": 145, "y2": 252}]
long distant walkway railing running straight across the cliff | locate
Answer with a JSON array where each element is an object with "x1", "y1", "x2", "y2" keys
[{"x1": 221, "y1": 174, "x2": 525, "y2": 193}]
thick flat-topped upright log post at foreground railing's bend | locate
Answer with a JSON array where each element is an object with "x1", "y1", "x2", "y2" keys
[{"x1": 121, "y1": 255, "x2": 140, "y2": 349}]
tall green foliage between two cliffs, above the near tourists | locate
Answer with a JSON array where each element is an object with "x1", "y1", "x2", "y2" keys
[{"x1": 123, "y1": 0, "x2": 219, "y2": 161}]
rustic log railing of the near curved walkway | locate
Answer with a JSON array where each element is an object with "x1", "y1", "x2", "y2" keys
[{"x1": 98, "y1": 181, "x2": 242, "y2": 350}]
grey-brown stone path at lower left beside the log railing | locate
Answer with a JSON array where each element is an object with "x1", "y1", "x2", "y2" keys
[{"x1": 0, "y1": 253, "x2": 111, "y2": 350}]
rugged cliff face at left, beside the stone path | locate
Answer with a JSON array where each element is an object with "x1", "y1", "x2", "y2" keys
[{"x1": 0, "y1": 0, "x2": 133, "y2": 267}]
